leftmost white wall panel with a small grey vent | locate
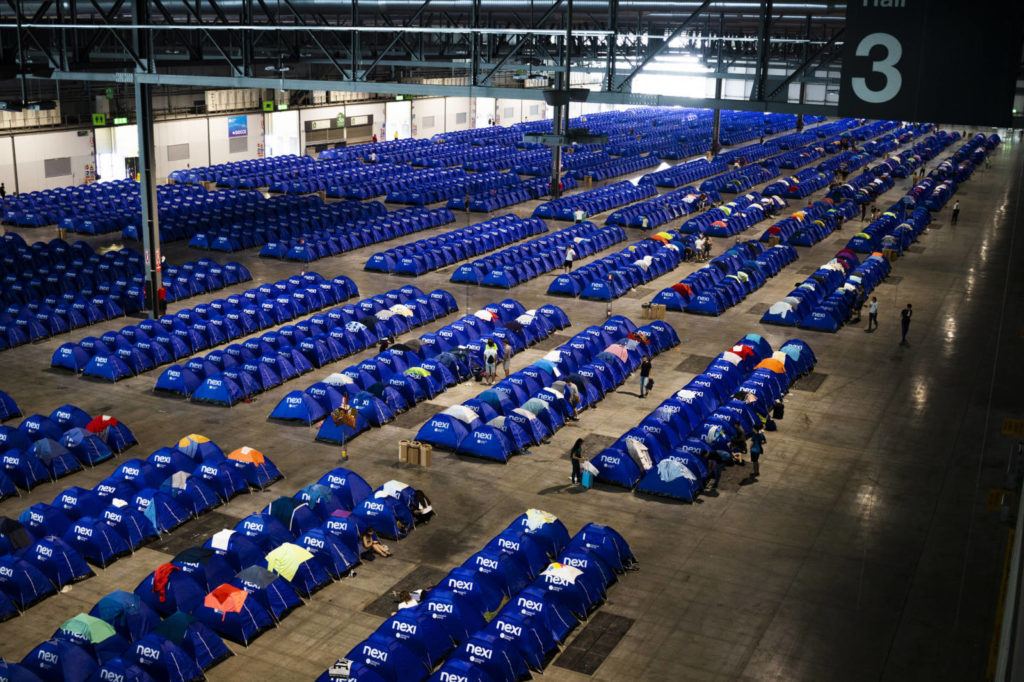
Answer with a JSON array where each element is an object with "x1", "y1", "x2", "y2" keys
[{"x1": 14, "y1": 130, "x2": 95, "y2": 191}]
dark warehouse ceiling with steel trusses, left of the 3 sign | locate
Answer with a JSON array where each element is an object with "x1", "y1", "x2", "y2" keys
[{"x1": 0, "y1": 0, "x2": 846, "y2": 111}]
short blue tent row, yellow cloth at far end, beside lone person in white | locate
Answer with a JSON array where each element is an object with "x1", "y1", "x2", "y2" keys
[{"x1": 548, "y1": 232, "x2": 686, "y2": 301}]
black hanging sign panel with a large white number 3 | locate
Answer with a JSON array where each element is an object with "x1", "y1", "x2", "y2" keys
[{"x1": 839, "y1": 0, "x2": 1024, "y2": 126}]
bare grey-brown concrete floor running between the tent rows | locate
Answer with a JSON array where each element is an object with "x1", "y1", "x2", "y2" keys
[{"x1": 0, "y1": 127, "x2": 1024, "y2": 681}]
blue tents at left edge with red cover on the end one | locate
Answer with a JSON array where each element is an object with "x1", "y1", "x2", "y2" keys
[{"x1": 0, "y1": 403, "x2": 137, "y2": 499}]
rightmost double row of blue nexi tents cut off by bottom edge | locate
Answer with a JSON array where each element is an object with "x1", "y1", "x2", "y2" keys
[{"x1": 317, "y1": 509, "x2": 636, "y2": 682}]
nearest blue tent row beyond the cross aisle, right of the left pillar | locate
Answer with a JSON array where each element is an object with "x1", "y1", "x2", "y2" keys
[{"x1": 253, "y1": 207, "x2": 455, "y2": 263}]
